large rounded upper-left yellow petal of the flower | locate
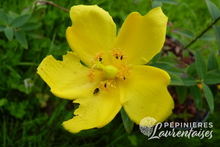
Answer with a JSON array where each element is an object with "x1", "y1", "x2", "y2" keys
[{"x1": 66, "y1": 5, "x2": 116, "y2": 66}]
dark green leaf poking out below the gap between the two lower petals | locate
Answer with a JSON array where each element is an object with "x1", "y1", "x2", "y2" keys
[{"x1": 121, "y1": 107, "x2": 134, "y2": 134}]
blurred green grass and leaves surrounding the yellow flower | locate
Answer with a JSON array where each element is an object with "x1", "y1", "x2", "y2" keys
[{"x1": 0, "y1": 0, "x2": 220, "y2": 147}]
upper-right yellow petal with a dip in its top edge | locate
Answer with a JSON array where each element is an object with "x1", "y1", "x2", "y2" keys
[{"x1": 114, "y1": 7, "x2": 168, "y2": 64}]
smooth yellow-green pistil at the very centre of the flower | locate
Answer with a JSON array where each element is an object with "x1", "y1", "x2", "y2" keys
[{"x1": 96, "y1": 62, "x2": 118, "y2": 79}]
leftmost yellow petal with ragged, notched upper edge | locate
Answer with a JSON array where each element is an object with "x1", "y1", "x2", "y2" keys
[{"x1": 37, "y1": 52, "x2": 102, "y2": 99}]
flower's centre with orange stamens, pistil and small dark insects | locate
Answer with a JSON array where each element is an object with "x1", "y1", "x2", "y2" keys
[{"x1": 88, "y1": 48, "x2": 131, "y2": 92}]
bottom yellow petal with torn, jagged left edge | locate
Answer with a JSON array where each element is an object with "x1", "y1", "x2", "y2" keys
[{"x1": 63, "y1": 87, "x2": 121, "y2": 133}]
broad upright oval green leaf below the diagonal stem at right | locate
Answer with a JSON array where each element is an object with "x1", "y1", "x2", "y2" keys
[{"x1": 195, "y1": 50, "x2": 207, "y2": 79}]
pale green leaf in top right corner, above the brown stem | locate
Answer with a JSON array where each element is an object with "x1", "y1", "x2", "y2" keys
[{"x1": 206, "y1": 0, "x2": 220, "y2": 20}]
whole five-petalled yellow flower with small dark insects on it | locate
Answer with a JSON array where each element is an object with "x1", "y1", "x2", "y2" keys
[{"x1": 38, "y1": 5, "x2": 174, "y2": 133}]
